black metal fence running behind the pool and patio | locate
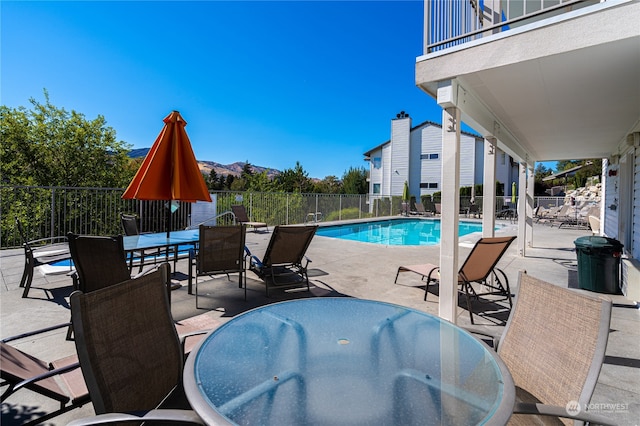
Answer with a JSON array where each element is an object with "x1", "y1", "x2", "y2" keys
[{"x1": 0, "y1": 185, "x2": 564, "y2": 248}]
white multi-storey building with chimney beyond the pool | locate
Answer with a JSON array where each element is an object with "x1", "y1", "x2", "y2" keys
[{"x1": 364, "y1": 111, "x2": 518, "y2": 205}]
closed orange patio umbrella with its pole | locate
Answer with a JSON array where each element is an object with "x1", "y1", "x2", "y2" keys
[{"x1": 122, "y1": 111, "x2": 211, "y2": 238}]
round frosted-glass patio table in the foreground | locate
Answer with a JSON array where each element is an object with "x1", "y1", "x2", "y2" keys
[{"x1": 184, "y1": 298, "x2": 515, "y2": 425}]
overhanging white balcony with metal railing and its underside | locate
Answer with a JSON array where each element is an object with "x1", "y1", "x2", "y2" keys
[{"x1": 416, "y1": 0, "x2": 640, "y2": 164}]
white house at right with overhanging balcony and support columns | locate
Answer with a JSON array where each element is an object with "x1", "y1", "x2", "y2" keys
[{"x1": 415, "y1": 0, "x2": 640, "y2": 321}]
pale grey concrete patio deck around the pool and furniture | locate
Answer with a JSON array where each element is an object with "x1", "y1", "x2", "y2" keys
[{"x1": 0, "y1": 221, "x2": 640, "y2": 425}]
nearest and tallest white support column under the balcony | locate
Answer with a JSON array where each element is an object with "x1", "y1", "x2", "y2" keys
[{"x1": 438, "y1": 107, "x2": 460, "y2": 324}]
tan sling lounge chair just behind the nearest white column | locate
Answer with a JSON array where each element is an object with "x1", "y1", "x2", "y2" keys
[{"x1": 394, "y1": 236, "x2": 516, "y2": 324}]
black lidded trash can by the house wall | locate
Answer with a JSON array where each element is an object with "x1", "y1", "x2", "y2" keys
[{"x1": 574, "y1": 236, "x2": 622, "y2": 294}]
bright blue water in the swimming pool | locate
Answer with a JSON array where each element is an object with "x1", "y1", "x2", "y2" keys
[{"x1": 316, "y1": 219, "x2": 482, "y2": 246}]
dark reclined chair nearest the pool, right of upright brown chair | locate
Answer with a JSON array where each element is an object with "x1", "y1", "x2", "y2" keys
[{"x1": 247, "y1": 225, "x2": 318, "y2": 297}]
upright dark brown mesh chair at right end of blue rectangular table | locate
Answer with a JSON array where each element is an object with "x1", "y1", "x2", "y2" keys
[{"x1": 189, "y1": 225, "x2": 247, "y2": 308}]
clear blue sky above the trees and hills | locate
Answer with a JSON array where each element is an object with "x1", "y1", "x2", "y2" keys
[{"x1": 0, "y1": 0, "x2": 556, "y2": 178}]
